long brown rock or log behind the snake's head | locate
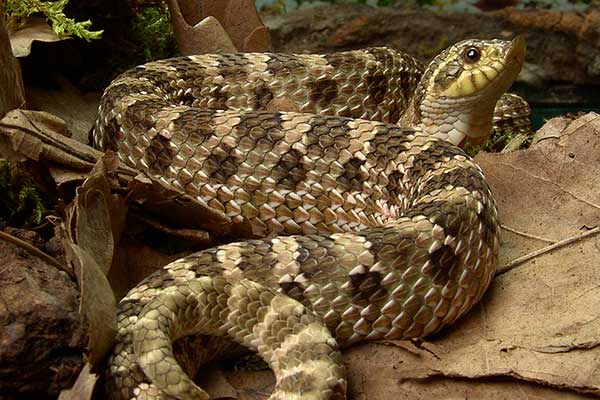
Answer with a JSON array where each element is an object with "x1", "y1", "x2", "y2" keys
[{"x1": 264, "y1": 4, "x2": 600, "y2": 85}]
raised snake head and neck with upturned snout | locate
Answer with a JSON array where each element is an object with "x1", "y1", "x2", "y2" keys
[{"x1": 411, "y1": 37, "x2": 525, "y2": 145}]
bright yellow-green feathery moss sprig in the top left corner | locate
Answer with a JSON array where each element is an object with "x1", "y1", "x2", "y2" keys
[{"x1": 2, "y1": 0, "x2": 102, "y2": 41}]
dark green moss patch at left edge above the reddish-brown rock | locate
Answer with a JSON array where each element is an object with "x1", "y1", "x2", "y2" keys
[{"x1": 0, "y1": 160, "x2": 46, "y2": 227}]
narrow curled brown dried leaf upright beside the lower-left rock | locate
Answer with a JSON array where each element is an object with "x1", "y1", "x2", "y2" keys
[{"x1": 64, "y1": 153, "x2": 127, "y2": 366}]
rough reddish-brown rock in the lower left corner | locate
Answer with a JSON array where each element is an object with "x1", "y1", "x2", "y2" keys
[{"x1": 0, "y1": 229, "x2": 87, "y2": 399}]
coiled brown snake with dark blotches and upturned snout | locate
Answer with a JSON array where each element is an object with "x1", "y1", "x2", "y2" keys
[{"x1": 93, "y1": 38, "x2": 525, "y2": 400}]
